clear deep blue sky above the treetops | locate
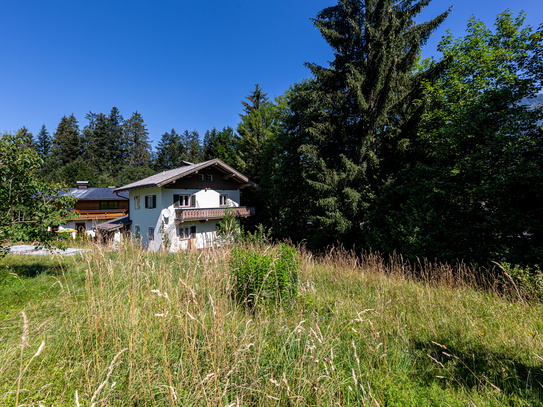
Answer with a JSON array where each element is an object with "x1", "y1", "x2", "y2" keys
[{"x1": 0, "y1": 0, "x2": 543, "y2": 144}]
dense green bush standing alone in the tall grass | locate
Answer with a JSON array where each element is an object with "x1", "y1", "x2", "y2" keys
[{"x1": 230, "y1": 243, "x2": 300, "y2": 308}]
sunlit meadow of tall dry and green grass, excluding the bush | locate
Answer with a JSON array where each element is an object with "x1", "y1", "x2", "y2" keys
[{"x1": 0, "y1": 241, "x2": 543, "y2": 407}]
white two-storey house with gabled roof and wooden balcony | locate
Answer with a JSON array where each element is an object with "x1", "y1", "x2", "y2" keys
[{"x1": 113, "y1": 158, "x2": 260, "y2": 251}]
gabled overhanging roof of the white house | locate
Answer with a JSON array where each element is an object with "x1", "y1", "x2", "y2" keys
[{"x1": 113, "y1": 158, "x2": 260, "y2": 193}]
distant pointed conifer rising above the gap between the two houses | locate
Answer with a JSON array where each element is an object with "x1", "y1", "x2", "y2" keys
[{"x1": 124, "y1": 111, "x2": 151, "y2": 167}]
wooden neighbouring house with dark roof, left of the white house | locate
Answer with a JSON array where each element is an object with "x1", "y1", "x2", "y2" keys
[{"x1": 63, "y1": 181, "x2": 129, "y2": 235}]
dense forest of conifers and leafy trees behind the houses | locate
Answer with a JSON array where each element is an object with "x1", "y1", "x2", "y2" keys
[{"x1": 5, "y1": 0, "x2": 543, "y2": 265}]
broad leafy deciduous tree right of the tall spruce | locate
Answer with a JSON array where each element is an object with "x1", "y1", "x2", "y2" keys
[{"x1": 365, "y1": 12, "x2": 543, "y2": 265}]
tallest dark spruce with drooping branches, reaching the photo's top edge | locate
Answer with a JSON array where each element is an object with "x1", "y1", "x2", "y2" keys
[{"x1": 278, "y1": 0, "x2": 450, "y2": 249}]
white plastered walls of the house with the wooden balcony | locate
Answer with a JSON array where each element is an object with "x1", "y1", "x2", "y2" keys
[{"x1": 129, "y1": 187, "x2": 239, "y2": 251}]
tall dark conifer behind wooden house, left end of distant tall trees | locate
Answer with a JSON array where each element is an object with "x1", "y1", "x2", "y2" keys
[{"x1": 51, "y1": 114, "x2": 82, "y2": 165}]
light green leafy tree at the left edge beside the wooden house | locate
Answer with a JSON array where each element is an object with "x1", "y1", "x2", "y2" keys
[{"x1": 0, "y1": 134, "x2": 77, "y2": 249}]
